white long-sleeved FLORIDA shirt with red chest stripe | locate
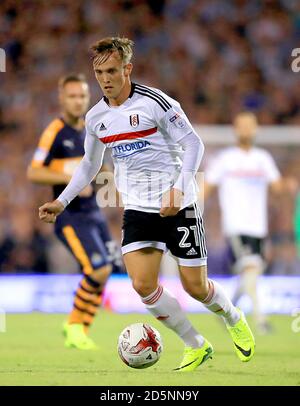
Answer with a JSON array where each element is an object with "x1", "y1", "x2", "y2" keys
[{"x1": 58, "y1": 84, "x2": 204, "y2": 213}]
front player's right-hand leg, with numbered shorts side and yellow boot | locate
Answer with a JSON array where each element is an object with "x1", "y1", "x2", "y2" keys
[{"x1": 167, "y1": 205, "x2": 254, "y2": 361}]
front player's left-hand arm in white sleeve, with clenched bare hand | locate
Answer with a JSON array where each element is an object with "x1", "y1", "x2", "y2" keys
[{"x1": 39, "y1": 125, "x2": 105, "y2": 223}]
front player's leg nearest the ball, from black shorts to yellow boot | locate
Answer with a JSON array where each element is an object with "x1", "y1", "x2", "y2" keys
[{"x1": 122, "y1": 210, "x2": 212, "y2": 371}]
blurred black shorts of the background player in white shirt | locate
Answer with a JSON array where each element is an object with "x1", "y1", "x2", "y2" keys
[{"x1": 227, "y1": 235, "x2": 265, "y2": 272}]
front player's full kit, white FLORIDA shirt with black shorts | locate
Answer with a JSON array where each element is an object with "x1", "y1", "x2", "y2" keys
[{"x1": 58, "y1": 84, "x2": 207, "y2": 266}]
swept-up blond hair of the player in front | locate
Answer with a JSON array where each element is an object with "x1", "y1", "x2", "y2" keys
[{"x1": 91, "y1": 37, "x2": 134, "y2": 65}]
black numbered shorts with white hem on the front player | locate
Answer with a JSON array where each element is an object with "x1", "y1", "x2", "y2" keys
[{"x1": 122, "y1": 204, "x2": 207, "y2": 266}]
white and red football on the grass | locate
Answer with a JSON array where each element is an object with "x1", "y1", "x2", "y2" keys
[{"x1": 118, "y1": 323, "x2": 163, "y2": 369}]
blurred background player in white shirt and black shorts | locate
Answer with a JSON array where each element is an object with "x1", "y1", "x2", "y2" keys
[{"x1": 204, "y1": 111, "x2": 297, "y2": 333}]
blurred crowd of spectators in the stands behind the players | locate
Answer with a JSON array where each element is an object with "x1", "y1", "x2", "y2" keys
[{"x1": 0, "y1": 0, "x2": 300, "y2": 273}]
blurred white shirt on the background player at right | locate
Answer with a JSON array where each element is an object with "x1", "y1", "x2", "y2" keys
[{"x1": 205, "y1": 147, "x2": 280, "y2": 238}]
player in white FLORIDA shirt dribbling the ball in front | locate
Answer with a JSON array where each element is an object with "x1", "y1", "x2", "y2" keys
[{"x1": 39, "y1": 37, "x2": 255, "y2": 371}]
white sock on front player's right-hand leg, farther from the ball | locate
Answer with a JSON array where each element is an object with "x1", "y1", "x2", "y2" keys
[{"x1": 201, "y1": 280, "x2": 240, "y2": 326}]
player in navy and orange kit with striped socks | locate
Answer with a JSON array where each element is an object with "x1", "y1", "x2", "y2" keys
[{"x1": 27, "y1": 75, "x2": 121, "y2": 350}]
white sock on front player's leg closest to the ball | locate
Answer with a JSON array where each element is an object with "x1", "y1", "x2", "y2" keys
[{"x1": 141, "y1": 286, "x2": 204, "y2": 348}]
